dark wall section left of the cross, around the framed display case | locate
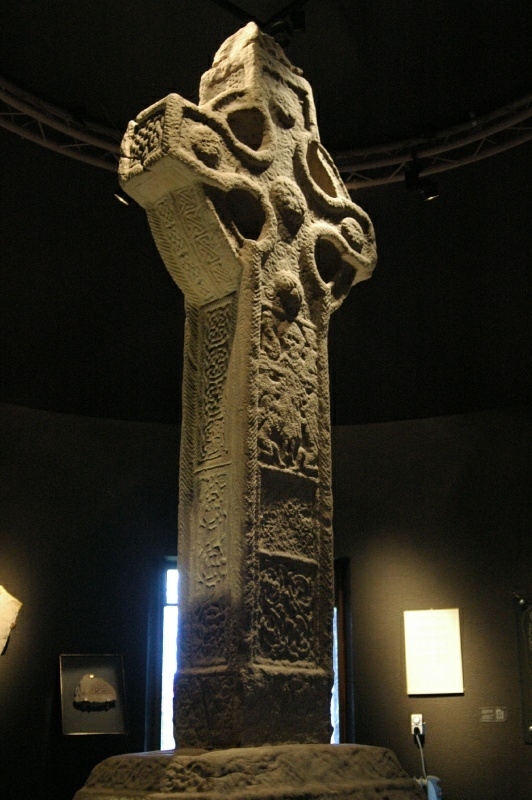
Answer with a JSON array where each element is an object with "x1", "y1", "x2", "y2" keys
[{"x1": 0, "y1": 405, "x2": 179, "y2": 800}]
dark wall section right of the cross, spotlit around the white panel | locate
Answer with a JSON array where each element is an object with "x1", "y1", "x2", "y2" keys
[{"x1": 333, "y1": 411, "x2": 532, "y2": 800}]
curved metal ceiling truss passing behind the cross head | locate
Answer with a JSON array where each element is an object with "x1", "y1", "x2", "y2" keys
[{"x1": 0, "y1": 73, "x2": 532, "y2": 190}]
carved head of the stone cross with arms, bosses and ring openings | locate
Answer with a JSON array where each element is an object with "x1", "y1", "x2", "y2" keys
[{"x1": 120, "y1": 23, "x2": 376, "y2": 322}]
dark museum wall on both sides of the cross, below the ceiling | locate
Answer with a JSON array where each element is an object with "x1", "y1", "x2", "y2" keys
[{"x1": 0, "y1": 405, "x2": 532, "y2": 800}]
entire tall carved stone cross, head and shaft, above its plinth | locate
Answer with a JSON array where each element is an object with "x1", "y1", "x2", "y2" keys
[{"x1": 120, "y1": 23, "x2": 375, "y2": 749}]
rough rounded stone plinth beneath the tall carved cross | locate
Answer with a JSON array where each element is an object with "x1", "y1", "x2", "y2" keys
[{"x1": 74, "y1": 745, "x2": 425, "y2": 800}]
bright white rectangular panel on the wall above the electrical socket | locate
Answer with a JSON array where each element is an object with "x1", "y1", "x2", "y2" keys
[{"x1": 404, "y1": 608, "x2": 464, "y2": 694}]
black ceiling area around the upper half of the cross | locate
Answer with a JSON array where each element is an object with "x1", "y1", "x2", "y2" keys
[{"x1": 0, "y1": 0, "x2": 532, "y2": 424}]
